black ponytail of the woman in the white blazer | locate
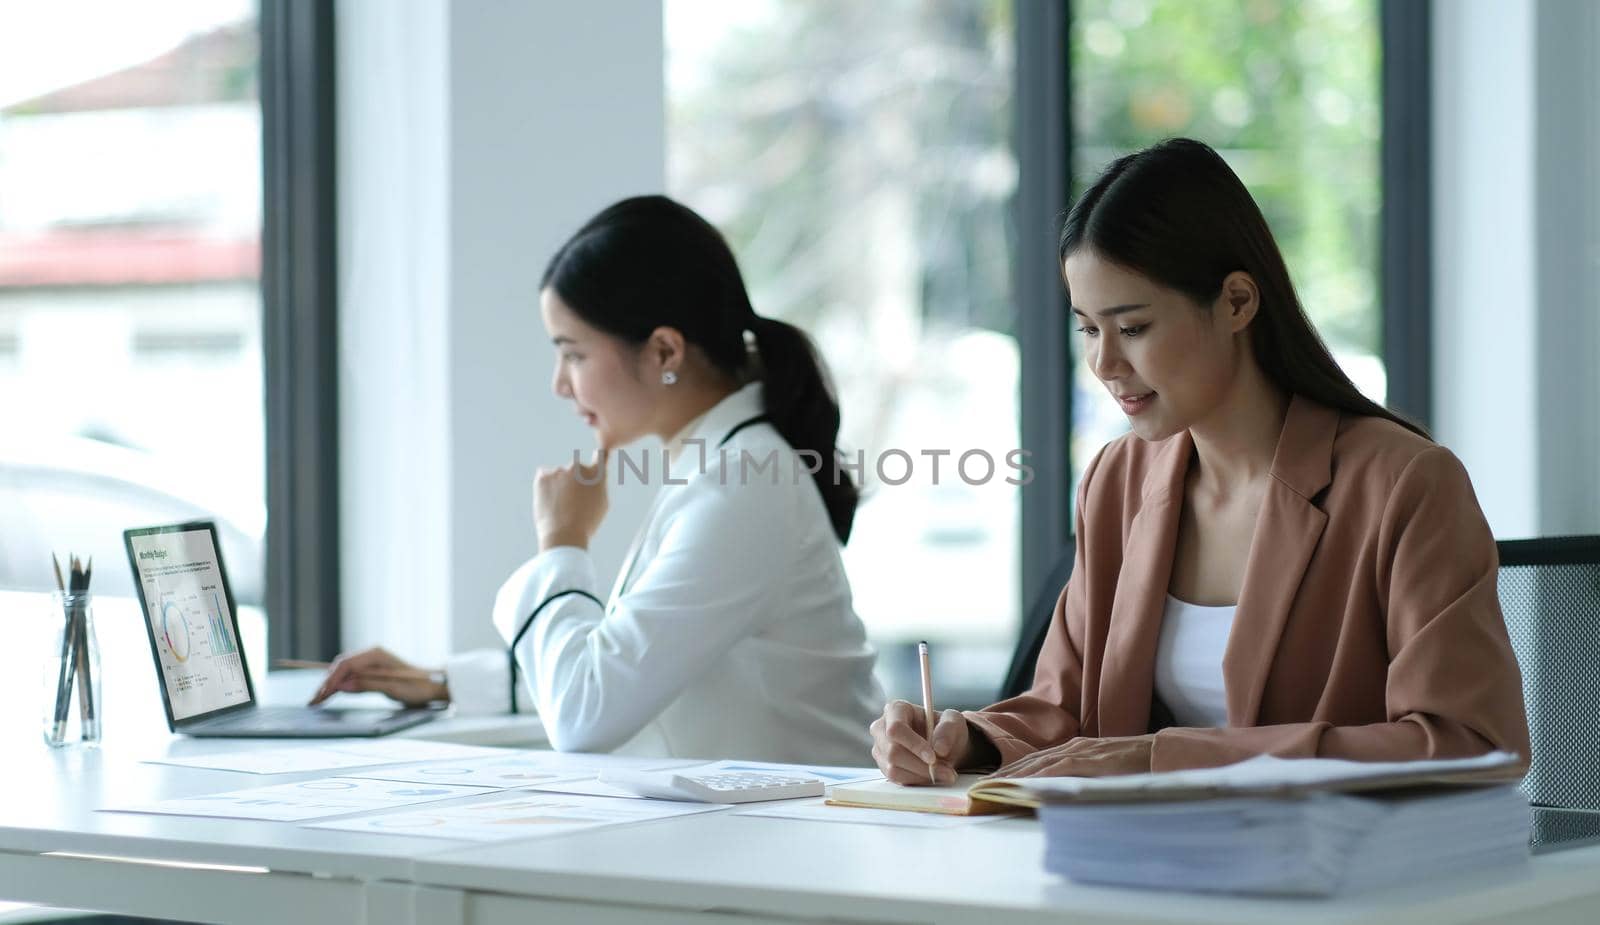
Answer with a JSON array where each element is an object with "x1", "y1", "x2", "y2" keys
[{"x1": 750, "y1": 317, "x2": 861, "y2": 544}]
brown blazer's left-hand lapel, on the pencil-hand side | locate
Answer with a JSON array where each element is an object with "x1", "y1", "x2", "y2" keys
[{"x1": 1083, "y1": 432, "x2": 1194, "y2": 736}]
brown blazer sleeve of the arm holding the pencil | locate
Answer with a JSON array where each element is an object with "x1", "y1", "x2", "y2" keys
[{"x1": 963, "y1": 450, "x2": 1104, "y2": 765}]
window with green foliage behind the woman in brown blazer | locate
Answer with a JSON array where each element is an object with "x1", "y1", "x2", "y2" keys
[{"x1": 1070, "y1": 0, "x2": 1388, "y2": 485}]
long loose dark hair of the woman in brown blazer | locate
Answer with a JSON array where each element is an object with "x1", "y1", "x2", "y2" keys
[{"x1": 1059, "y1": 138, "x2": 1427, "y2": 437}]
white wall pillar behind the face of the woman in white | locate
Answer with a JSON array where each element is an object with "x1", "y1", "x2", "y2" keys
[{"x1": 336, "y1": 0, "x2": 666, "y2": 661}]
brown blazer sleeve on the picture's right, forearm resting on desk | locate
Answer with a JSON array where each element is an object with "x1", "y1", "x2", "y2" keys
[{"x1": 1150, "y1": 446, "x2": 1530, "y2": 775}]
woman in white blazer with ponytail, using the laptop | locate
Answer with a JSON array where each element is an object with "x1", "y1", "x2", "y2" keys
[{"x1": 312, "y1": 197, "x2": 883, "y2": 765}]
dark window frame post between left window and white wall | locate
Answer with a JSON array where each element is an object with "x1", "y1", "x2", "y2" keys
[{"x1": 258, "y1": 0, "x2": 339, "y2": 659}]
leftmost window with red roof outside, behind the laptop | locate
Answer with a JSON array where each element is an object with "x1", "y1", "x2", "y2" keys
[{"x1": 0, "y1": 0, "x2": 266, "y2": 646}]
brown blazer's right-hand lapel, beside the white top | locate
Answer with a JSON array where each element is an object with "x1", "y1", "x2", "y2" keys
[{"x1": 1222, "y1": 395, "x2": 1339, "y2": 727}]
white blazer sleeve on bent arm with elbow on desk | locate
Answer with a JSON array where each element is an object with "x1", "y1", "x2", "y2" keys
[{"x1": 517, "y1": 475, "x2": 796, "y2": 752}]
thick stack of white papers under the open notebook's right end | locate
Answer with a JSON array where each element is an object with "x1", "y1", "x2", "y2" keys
[{"x1": 1034, "y1": 757, "x2": 1531, "y2": 896}]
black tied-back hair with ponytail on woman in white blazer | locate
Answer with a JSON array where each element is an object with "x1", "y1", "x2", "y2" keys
[{"x1": 539, "y1": 195, "x2": 859, "y2": 543}]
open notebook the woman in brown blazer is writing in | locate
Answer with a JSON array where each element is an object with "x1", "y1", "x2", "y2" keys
[{"x1": 827, "y1": 752, "x2": 1520, "y2": 816}]
